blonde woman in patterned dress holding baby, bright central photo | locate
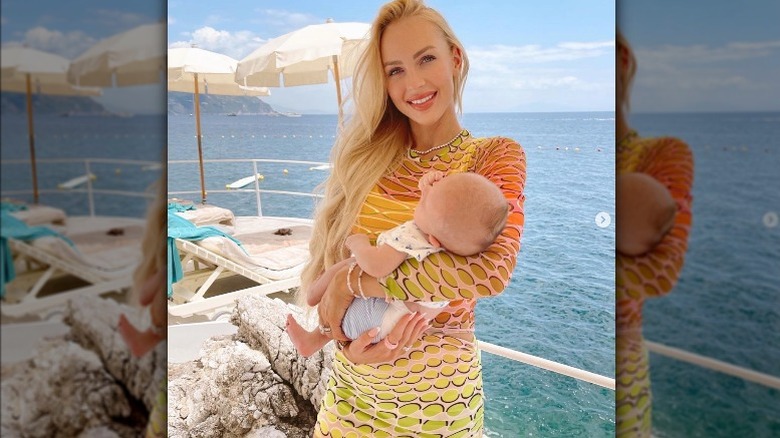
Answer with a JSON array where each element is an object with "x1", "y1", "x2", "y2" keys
[{"x1": 301, "y1": 0, "x2": 525, "y2": 437}]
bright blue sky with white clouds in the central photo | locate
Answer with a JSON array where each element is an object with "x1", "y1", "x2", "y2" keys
[{"x1": 168, "y1": 0, "x2": 615, "y2": 113}]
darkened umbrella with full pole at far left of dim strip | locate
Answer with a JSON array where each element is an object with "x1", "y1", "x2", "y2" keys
[{"x1": 0, "y1": 46, "x2": 100, "y2": 204}]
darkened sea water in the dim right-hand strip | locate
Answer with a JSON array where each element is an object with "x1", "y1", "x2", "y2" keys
[{"x1": 632, "y1": 112, "x2": 780, "y2": 437}]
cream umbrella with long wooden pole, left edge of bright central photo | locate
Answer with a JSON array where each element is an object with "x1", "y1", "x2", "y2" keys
[{"x1": 168, "y1": 47, "x2": 271, "y2": 204}]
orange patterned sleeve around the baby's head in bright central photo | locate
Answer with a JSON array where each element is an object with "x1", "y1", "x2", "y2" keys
[{"x1": 380, "y1": 137, "x2": 526, "y2": 301}]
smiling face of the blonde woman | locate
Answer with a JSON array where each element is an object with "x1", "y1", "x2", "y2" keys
[{"x1": 380, "y1": 17, "x2": 461, "y2": 125}]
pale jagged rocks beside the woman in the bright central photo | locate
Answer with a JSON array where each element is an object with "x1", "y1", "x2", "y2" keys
[{"x1": 168, "y1": 297, "x2": 332, "y2": 437}]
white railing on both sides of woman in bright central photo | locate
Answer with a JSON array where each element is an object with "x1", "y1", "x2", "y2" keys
[{"x1": 168, "y1": 158, "x2": 615, "y2": 391}]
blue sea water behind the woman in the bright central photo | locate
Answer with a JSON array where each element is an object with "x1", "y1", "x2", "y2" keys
[{"x1": 168, "y1": 112, "x2": 615, "y2": 437}]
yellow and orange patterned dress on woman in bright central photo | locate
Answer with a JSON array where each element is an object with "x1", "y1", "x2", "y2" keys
[{"x1": 314, "y1": 130, "x2": 526, "y2": 437}]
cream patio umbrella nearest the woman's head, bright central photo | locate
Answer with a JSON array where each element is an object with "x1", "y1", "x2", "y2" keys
[{"x1": 236, "y1": 20, "x2": 370, "y2": 121}]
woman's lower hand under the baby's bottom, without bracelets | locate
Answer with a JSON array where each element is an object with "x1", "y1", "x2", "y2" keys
[{"x1": 342, "y1": 312, "x2": 430, "y2": 365}]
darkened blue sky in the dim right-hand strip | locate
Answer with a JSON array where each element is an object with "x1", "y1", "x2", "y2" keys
[{"x1": 617, "y1": 0, "x2": 780, "y2": 112}]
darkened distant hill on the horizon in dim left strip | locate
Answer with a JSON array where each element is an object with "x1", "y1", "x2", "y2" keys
[{"x1": 0, "y1": 92, "x2": 110, "y2": 115}]
